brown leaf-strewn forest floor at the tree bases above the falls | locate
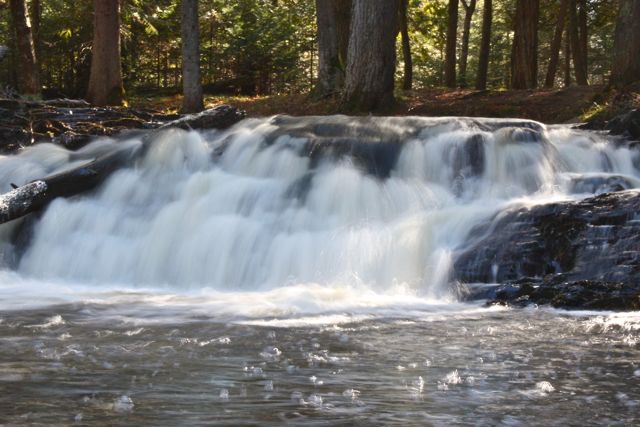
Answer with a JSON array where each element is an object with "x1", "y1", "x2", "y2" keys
[{"x1": 130, "y1": 86, "x2": 640, "y2": 124}]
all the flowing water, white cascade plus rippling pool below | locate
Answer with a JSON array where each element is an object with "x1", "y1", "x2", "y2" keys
[{"x1": 0, "y1": 117, "x2": 640, "y2": 426}]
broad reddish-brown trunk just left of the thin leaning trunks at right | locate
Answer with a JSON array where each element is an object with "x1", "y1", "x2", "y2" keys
[{"x1": 511, "y1": 0, "x2": 540, "y2": 89}]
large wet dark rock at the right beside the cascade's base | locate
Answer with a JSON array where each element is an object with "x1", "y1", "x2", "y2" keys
[{"x1": 454, "y1": 190, "x2": 640, "y2": 310}]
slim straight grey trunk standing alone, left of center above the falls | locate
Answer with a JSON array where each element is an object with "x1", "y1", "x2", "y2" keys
[{"x1": 181, "y1": 0, "x2": 204, "y2": 113}]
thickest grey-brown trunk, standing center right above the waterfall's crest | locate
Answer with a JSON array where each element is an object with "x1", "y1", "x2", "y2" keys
[{"x1": 342, "y1": 0, "x2": 398, "y2": 111}]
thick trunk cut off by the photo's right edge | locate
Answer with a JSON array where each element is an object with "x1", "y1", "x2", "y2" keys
[{"x1": 611, "y1": 0, "x2": 640, "y2": 87}]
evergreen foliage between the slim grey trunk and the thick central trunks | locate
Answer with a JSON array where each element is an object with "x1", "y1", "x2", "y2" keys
[{"x1": 201, "y1": 0, "x2": 315, "y2": 95}]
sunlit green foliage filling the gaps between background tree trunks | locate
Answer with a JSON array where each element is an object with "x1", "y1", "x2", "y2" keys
[{"x1": 0, "y1": 0, "x2": 617, "y2": 97}]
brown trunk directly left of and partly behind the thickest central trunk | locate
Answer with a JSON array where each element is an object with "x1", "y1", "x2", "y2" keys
[{"x1": 316, "y1": 0, "x2": 351, "y2": 97}]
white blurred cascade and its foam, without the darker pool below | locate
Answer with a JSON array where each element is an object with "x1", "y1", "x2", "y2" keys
[{"x1": 0, "y1": 117, "x2": 640, "y2": 317}]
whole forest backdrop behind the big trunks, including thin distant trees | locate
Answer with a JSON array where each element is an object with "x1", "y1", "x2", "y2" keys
[{"x1": 0, "y1": 0, "x2": 636, "y2": 120}]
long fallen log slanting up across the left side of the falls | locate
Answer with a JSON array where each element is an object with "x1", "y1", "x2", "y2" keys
[{"x1": 0, "y1": 105, "x2": 244, "y2": 224}]
